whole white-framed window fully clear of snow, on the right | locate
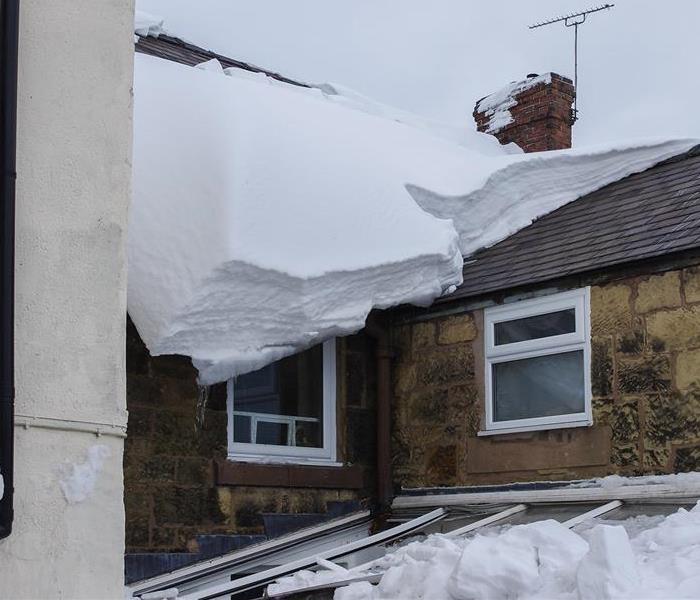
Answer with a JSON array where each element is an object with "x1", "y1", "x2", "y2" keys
[{"x1": 482, "y1": 288, "x2": 591, "y2": 435}]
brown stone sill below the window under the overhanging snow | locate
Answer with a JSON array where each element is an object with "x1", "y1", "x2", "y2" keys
[{"x1": 215, "y1": 459, "x2": 366, "y2": 490}]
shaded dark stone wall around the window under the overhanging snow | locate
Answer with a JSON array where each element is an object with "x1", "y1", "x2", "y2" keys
[{"x1": 124, "y1": 322, "x2": 375, "y2": 553}]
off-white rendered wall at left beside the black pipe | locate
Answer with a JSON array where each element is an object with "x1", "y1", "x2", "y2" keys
[{"x1": 0, "y1": 0, "x2": 133, "y2": 599}]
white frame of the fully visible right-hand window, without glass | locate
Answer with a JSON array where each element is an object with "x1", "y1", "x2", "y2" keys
[{"x1": 479, "y1": 287, "x2": 593, "y2": 435}]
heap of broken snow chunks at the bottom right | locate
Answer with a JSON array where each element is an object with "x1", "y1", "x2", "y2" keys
[{"x1": 268, "y1": 503, "x2": 700, "y2": 600}]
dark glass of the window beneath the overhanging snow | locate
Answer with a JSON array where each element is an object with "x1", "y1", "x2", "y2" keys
[{"x1": 233, "y1": 344, "x2": 323, "y2": 448}]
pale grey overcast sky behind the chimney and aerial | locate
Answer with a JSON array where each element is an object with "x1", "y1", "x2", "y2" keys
[{"x1": 137, "y1": 0, "x2": 700, "y2": 145}]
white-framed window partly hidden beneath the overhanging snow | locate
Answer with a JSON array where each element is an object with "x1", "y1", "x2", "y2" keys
[{"x1": 227, "y1": 340, "x2": 336, "y2": 464}]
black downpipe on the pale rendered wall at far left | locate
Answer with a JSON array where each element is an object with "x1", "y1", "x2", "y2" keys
[{"x1": 0, "y1": 0, "x2": 19, "y2": 539}]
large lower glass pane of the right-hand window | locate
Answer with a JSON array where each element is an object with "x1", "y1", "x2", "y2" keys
[{"x1": 492, "y1": 350, "x2": 585, "y2": 421}]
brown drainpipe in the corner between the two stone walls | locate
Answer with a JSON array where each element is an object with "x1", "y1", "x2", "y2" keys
[{"x1": 365, "y1": 314, "x2": 394, "y2": 511}]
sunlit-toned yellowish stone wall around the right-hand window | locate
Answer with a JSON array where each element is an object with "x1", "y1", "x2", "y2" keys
[{"x1": 393, "y1": 267, "x2": 700, "y2": 487}]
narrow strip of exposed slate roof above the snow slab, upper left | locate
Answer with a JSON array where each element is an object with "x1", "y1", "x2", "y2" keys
[{"x1": 135, "y1": 34, "x2": 311, "y2": 88}]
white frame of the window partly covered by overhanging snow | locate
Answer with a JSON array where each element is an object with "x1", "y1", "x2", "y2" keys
[{"x1": 226, "y1": 338, "x2": 338, "y2": 466}]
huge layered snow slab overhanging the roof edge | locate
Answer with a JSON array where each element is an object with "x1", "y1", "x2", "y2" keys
[{"x1": 128, "y1": 50, "x2": 697, "y2": 384}]
